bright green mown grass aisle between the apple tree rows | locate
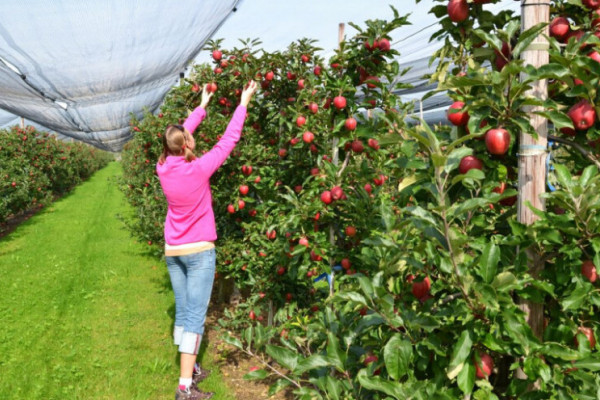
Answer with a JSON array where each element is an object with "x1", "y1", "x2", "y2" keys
[{"x1": 0, "y1": 162, "x2": 233, "y2": 400}]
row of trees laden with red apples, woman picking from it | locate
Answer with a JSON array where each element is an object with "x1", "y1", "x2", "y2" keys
[{"x1": 123, "y1": 0, "x2": 600, "y2": 399}]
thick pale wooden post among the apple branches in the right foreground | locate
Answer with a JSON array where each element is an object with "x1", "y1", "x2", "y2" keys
[{"x1": 517, "y1": 0, "x2": 550, "y2": 377}]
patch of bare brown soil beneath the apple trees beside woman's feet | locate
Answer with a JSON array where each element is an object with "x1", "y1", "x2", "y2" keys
[{"x1": 206, "y1": 303, "x2": 294, "y2": 400}]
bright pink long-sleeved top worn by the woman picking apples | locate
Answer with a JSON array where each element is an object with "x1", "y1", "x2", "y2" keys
[{"x1": 156, "y1": 105, "x2": 246, "y2": 245}]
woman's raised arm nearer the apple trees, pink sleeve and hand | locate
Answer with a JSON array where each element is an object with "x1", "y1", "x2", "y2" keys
[{"x1": 195, "y1": 81, "x2": 257, "y2": 176}]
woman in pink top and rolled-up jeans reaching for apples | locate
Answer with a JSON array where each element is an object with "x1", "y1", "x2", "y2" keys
[{"x1": 156, "y1": 81, "x2": 257, "y2": 400}]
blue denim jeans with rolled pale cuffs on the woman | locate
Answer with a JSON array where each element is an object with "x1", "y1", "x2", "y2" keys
[{"x1": 166, "y1": 248, "x2": 216, "y2": 354}]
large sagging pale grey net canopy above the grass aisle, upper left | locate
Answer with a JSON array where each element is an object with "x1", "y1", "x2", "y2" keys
[{"x1": 0, "y1": 0, "x2": 238, "y2": 151}]
